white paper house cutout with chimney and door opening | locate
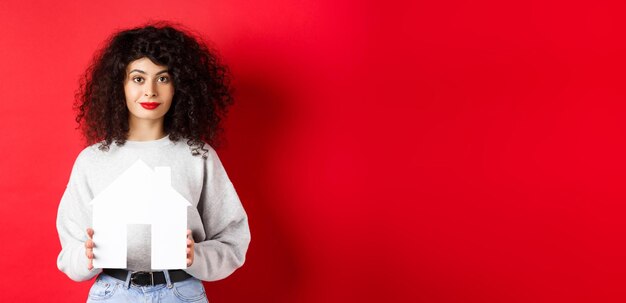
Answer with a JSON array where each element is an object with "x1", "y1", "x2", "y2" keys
[{"x1": 91, "y1": 159, "x2": 191, "y2": 270}]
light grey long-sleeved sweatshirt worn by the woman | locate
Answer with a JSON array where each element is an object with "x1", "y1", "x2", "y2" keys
[{"x1": 56, "y1": 136, "x2": 250, "y2": 281}]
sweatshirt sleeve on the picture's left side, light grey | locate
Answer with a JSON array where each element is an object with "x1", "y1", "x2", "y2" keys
[{"x1": 56, "y1": 155, "x2": 102, "y2": 281}]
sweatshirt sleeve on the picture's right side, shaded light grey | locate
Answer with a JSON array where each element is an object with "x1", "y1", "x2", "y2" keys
[{"x1": 186, "y1": 147, "x2": 250, "y2": 281}]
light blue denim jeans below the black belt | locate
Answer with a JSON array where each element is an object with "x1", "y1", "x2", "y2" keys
[{"x1": 87, "y1": 271, "x2": 209, "y2": 303}]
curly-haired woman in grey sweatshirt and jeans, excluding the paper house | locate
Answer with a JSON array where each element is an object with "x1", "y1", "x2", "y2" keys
[{"x1": 57, "y1": 22, "x2": 250, "y2": 302}]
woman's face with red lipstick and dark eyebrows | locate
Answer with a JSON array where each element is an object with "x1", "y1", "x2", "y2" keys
[{"x1": 124, "y1": 57, "x2": 174, "y2": 125}]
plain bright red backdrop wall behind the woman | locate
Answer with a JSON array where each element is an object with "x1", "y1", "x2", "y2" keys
[{"x1": 0, "y1": 0, "x2": 626, "y2": 302}]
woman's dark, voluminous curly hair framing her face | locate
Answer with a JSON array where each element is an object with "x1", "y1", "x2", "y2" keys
[{"x1": 74, "y1": 21, "x2": 233, "y2": 158}]
